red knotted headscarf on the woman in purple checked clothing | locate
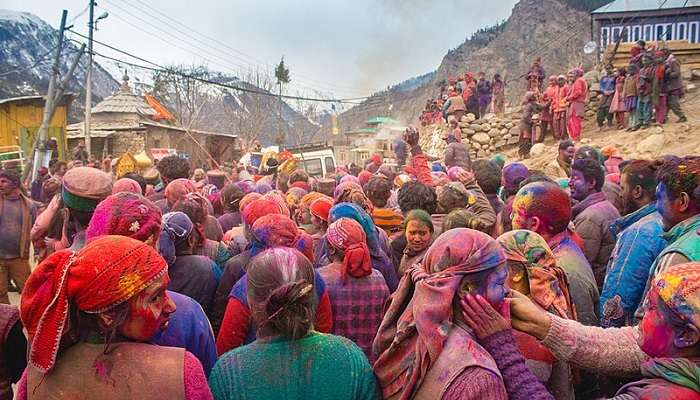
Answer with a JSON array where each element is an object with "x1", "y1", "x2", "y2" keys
[{"x1": 326, "y1": 218, "x2": 372, "y2": 282}]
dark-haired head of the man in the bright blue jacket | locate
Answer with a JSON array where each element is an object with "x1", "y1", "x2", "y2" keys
[{"x1": 620, "y1": 160, "x2": 659, "y2": 215}]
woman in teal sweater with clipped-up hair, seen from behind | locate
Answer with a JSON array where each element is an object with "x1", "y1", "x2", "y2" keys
[{"x1": 209, "y1": 248, "x2": 379, "y2": 400}]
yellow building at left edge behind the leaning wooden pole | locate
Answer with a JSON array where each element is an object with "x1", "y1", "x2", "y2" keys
[{"x1": 0, "y1": 93, "x2": 76, "y2": 162}]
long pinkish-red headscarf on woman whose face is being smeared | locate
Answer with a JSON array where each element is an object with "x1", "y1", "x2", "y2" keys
[{"x1": 374, "y1": 228, "x2": 506, "y2": 399}]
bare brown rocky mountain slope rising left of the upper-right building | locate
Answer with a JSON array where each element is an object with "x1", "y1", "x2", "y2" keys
[{"x1": 339, "y1": 0, "x2": 600, "y2": 130}]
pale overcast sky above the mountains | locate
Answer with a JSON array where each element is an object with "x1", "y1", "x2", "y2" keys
[{"x1": 5, "y1": 0, "x2": 517, "y2": 97}]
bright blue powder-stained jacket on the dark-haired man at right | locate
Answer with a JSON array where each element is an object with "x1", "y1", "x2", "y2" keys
[{"x1": 598, "y1": 203, "x2": 667, "y2": 328}]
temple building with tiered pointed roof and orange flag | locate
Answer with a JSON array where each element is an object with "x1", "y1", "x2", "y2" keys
[{"x1": 68, "y1": 75, "x2": 241, "y2": 168}]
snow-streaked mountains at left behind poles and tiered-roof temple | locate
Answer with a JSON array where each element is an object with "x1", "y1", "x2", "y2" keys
[{"x1": 0, "y1": 9, "x2": 319, "y2": 145}]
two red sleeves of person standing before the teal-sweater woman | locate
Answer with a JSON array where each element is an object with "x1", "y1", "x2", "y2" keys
[{"x1": 216, "y1": 291, "x2": 333, "y2": 355}]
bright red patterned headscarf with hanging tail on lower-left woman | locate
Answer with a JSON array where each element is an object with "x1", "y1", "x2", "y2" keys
[{"x1": 20, "y1": 236, "x2": 168, "y2": 373}]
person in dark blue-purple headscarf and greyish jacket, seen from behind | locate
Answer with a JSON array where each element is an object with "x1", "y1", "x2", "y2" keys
[{"x1": 158, "y1": 211, "x2": 221, "y2": 312}]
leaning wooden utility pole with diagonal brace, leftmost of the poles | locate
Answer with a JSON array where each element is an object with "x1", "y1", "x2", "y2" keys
[{"x1": 22, "y1": 10, "x2": 85, "y2": 180}]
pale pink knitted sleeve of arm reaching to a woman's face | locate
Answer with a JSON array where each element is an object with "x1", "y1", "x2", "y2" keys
[{"x1": 542, "y1": 314, "x2": 649, "y2": 376}]
